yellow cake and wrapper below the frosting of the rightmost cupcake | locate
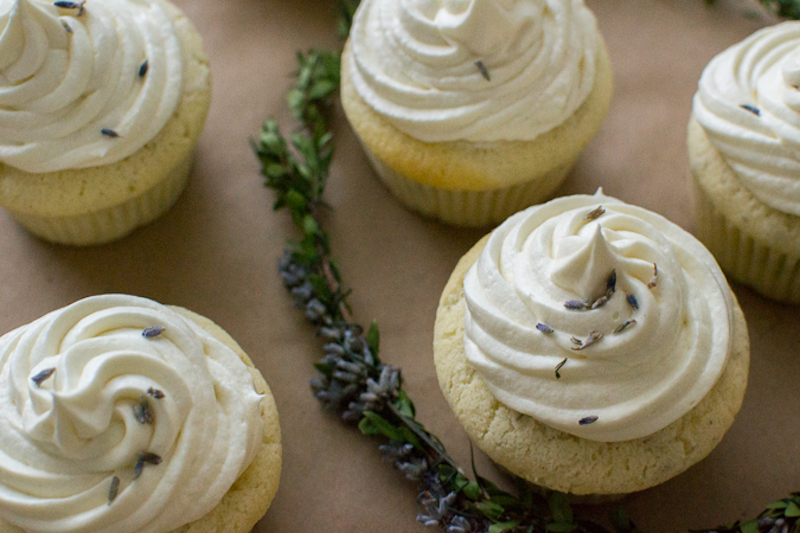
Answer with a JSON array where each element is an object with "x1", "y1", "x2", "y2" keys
[{"x1": 687, "y1": 116, "x2": 800, "y2": 303}]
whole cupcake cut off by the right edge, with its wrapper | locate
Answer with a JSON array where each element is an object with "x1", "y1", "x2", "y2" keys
[{"x1": 687, "y1": 22, "x2": 800, "y2": 303}]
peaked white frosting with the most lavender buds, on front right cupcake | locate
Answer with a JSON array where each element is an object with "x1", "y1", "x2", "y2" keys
[{"x1": 464, "y1": 192, "x2": 732, "y2": 441}]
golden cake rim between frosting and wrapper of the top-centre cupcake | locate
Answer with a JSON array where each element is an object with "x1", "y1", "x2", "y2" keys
[{"x1": 341, "y1": 33, "x2": 613, "y2": 191}]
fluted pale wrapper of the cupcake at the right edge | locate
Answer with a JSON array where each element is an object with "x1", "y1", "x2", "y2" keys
[{"x1": 693, "y1": 181, "x2": 800, "y2": 303}]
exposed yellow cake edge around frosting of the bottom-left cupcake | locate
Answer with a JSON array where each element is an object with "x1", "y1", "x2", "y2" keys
[{"x1": 0, "y1": 306, "x2": 282, "y2": 533}]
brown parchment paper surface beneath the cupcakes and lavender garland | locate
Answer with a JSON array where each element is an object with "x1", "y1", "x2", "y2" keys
[{"x1": 0, "y1": 0, "x2": 800, "y2": 533}]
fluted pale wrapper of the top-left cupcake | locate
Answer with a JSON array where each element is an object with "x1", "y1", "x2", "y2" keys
[{"x1": 11, "y1": 152, "x2": 192, "y2": 246}]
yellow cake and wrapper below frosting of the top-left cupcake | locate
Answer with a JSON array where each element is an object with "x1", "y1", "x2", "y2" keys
[{"x1": 0, "y1": 2, "x2": 211, "y2": 244}]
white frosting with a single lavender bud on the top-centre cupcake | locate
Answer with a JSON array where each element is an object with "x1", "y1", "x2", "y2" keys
[{"x1": 349, "y1": 0, "x2": 599, "y2": 142}]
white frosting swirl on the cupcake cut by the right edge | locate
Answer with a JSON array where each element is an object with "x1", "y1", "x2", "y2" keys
[{"x1": 693, "y1": 22, "x2": 800, "y2": 216}]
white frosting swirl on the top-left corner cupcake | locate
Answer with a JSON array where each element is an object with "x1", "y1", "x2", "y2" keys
[{"x1": 0, "y1": 0, "x2": 183, "y2": 173}]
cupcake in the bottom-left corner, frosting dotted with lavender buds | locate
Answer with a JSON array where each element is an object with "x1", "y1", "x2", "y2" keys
[{"x1": 0, "y1": 294, "x2": 281, "y2": 533}]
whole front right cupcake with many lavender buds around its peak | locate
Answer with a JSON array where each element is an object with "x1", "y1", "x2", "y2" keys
[{"x1": 433, "y1": 192, "x2": 750, "y2": 495}]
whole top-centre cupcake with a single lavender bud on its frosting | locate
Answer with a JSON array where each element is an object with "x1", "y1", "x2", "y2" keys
[{"x1": 341, "y1": 0, "x2": 611, "y2": 226}]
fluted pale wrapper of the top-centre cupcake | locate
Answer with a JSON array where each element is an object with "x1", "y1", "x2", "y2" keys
[{"x1": 362, "y1": 143, "x2": 575, "y2": 227}]
